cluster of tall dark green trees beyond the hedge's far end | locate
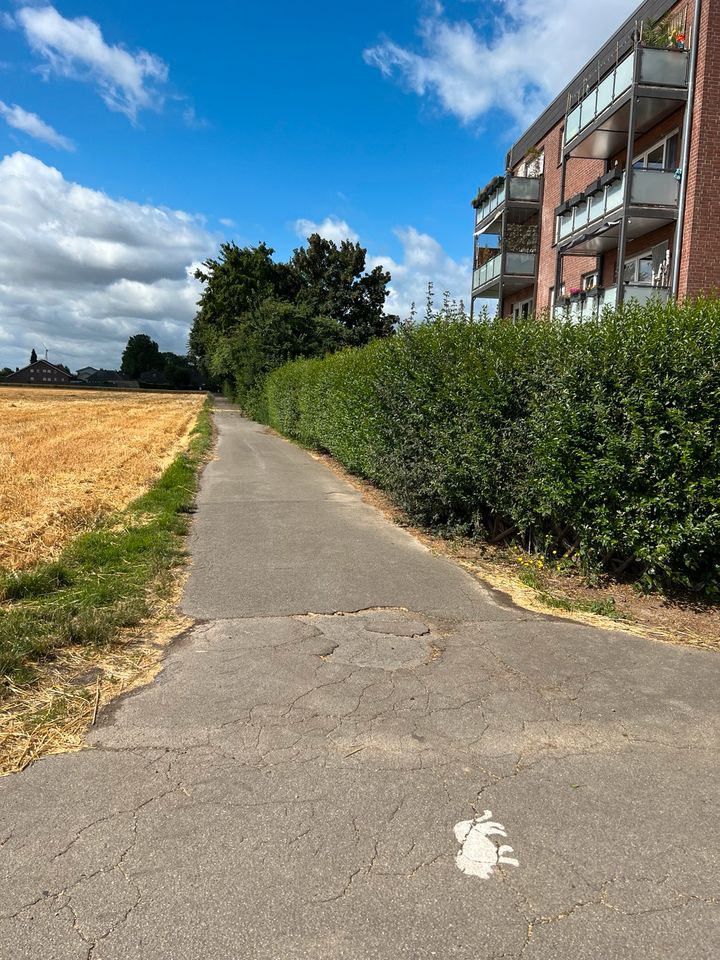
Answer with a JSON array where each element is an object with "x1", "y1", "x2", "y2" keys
[{"x1": 190, "y1": 234, "x2": 397, "y2": 403}]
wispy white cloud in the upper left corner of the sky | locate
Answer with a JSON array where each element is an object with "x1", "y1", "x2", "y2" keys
[{"x1": 16, "y1": 6, "x2": 168, "y2": 122}]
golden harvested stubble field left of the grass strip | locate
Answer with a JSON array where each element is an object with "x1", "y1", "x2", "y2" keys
[{"x1": 0, "y1": 387, "x2": 205, "y2": 570}]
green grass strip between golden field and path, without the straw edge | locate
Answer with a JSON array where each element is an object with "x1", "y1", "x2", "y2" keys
[{"x1": 0, "y1": 400, "x2": 212, "y2": 699}]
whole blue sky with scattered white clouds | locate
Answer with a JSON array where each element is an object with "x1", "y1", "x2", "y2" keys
[{"x1": 0, "y1": 0, "x2": 634, "y2": 368}]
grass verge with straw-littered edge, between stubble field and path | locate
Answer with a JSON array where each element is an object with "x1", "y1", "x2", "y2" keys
[{"x1": 0, "y1": 401, "x2": 212, "y2": 775}]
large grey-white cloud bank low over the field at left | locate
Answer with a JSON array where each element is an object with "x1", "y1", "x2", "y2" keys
[{"x1": 0, "y1": 153, "x2": 216, "y2": 369}]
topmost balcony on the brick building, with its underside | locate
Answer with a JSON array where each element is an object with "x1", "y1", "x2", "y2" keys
[{"x1": 565, "y1": 47, "x2": 690, "y2": 160}]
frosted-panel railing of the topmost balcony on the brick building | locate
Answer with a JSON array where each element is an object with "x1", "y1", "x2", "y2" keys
[{"x1": 565, "y1": 47, "x2": 689, "y2": 144}]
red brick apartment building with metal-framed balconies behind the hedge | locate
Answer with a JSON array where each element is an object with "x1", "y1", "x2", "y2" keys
[{"x1": 471, "y1": 0, "x2": 720, "y2": 318}]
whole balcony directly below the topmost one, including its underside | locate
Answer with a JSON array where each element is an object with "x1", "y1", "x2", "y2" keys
[{"x1": 557, "y1": 168, "x2": 680, "y2": 256}]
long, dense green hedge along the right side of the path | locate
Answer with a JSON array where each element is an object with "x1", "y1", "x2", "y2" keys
[{"x1": 257, "y1": 300, "x2": 720, "y2": 597}]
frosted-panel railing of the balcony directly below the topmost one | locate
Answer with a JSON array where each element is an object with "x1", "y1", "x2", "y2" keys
[{"x1": 558, "y1": 169, "x2": 680, "y2": 242}]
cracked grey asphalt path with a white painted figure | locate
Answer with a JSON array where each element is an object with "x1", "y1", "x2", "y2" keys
[{"x1": 0, "y1": 407, "x2": 720, "y2": 960}]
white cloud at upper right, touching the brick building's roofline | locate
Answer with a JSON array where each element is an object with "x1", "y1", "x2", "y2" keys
[{"x1": 364, "y1": 0, "x2": 636, "y2": 126}]
